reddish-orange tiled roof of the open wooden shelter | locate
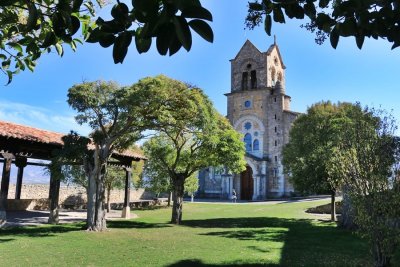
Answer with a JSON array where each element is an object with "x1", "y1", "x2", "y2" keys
[{"x1": 0, "y1": 120, "x2": 146, "y2": 159}]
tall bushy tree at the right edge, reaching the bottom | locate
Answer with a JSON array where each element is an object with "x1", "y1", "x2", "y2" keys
[{"x1": 330, "y1": 108, "x2": 400, "y2": 266}]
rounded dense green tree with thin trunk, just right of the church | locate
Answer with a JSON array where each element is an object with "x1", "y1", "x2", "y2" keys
[{"x1": 283, "y1": 102, "x2": 368, "y2": 221}]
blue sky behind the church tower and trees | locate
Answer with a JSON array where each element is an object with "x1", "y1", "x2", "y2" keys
[{"x1": 0, "y1": 0, "x2": 400, "y2": 184}]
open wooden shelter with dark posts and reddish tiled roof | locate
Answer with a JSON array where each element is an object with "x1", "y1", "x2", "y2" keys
[{"x1": 0, "y1": 121, "x2": 145, "y2": 225}]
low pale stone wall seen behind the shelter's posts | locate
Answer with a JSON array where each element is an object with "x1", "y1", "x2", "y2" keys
[{"x1": 8, "y1": 184, "x2": 153, "y2": 204}]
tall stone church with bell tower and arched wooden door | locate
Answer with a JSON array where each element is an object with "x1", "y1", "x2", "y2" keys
[{"x1": 198, "y1": 40, "x2": 299, "y2": 200}]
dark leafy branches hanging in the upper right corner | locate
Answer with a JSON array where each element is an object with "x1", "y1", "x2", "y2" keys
[{"x1": 246, "y1": 0, "x2": 400, "y2": 49}]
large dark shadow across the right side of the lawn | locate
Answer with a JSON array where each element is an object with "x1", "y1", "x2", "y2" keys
[{"x1": 183, "y1": 217, "x2": 370, "y2": 266}]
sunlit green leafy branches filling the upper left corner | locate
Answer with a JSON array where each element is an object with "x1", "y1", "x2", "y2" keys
[{"x1": 0, "y1": 0, "x2": 102, "y2": 83}]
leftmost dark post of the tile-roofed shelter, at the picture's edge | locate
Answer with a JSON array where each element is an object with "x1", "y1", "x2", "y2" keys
[{"x1": 0, "y1": 154, "x2": 12, "y2": 228}]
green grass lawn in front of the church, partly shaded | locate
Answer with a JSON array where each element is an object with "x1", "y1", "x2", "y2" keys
[{"x1": 0, "y1": 201, "x2": 390, "y2": 267}]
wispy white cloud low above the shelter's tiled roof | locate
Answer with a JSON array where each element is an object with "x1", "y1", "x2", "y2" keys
[{"x1": 0, "y1": 101, "x2": 90, "y2": 135}]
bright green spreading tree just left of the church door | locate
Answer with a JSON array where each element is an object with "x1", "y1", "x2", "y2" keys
[{"x1": 143, "y1": 76, "x2": 245, "y2": 224}]
